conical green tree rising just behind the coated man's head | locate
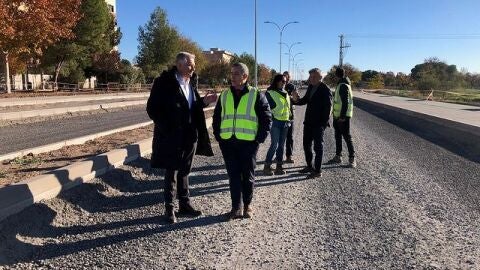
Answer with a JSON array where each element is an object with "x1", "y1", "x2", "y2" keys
[{"x1": 136, "y1": 7, "x2": 180, "y2": 79}]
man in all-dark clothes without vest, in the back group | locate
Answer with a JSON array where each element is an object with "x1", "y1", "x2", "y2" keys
[{"x1": 293, "y1": 68, "x2": 332, "y2": 178}]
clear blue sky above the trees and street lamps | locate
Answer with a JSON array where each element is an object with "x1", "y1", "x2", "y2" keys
[{"x1": 117, "y1": 0, "x2": 480, "y2": 77}]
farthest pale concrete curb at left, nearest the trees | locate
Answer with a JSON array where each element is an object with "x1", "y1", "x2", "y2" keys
[{"x1": 0, "y1": 92, "x2": 150, "y2": 107}]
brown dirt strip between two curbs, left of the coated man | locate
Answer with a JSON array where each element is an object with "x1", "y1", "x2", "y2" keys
[{"x1": 0, "y1": 125, "x2": 153, "y2": 187}]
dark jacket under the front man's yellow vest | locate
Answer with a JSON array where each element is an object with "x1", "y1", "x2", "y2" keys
[{"x1": 212, "y1": 85, "x2": 272, "y2": 143}]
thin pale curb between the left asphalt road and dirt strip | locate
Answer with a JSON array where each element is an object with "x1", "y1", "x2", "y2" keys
[{"x1": 0, "y1": 121, "x2": 153, "y2": 161}]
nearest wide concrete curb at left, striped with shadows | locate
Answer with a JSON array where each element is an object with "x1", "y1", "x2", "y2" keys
[{"x1": 0, "y1": 118, "x2": 212, "y2": 221}]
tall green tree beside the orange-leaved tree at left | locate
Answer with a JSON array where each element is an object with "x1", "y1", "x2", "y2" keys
[{"x1": 41, "y1": 0, "x2": 121, "y2": 86}]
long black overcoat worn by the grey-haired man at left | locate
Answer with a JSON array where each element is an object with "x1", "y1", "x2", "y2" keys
[{"x1": 147, "y1": 68, "x2": 213, "y2": 169}]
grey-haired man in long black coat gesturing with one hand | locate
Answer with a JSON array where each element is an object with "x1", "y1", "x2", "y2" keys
[{"x1": 147, "y1": 52, "x2": 217, "y2": 223}]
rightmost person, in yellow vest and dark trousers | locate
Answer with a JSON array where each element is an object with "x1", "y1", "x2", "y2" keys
[{"x1": 327, "y1": 68, "x2": 357, "y2": 168}]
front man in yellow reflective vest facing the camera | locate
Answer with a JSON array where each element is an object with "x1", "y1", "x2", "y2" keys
[{"x1": 212, "y1": 63, "x2": 272, "y2": 220}]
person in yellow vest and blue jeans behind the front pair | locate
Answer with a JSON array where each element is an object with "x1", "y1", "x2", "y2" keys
[{"x1": 263, "y1": 74, "x2": 292, "y2": 175}]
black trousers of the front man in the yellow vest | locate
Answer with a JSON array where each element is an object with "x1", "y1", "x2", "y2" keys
[{"x1": 220, "y1": 139, "x2": 258, "y2": 210}]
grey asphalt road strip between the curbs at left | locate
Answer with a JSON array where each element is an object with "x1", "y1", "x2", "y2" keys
[{"x1": 0, "y1": 106, "x2": 150, "y2": 155}]
